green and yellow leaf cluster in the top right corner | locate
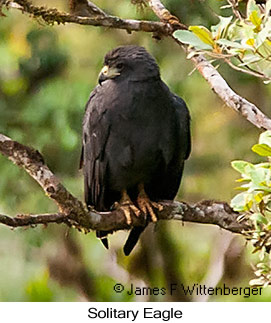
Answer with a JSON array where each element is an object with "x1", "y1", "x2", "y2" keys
[{"x1": 174, "y1": 0, "x2": 271, "y2": 83}]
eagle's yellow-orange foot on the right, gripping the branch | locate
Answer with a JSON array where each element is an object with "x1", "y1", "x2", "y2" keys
[{"x1": 137, "y1": 185, "x2": 163, "y2": 222}]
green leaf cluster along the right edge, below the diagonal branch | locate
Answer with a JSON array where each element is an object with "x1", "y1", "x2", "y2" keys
[{"x1": 231, "y1": 131, "x2": 271, "y2": 285}]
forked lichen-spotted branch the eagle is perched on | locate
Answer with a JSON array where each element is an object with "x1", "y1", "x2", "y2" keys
[{"x1": 0, "y1": 134, "x2": 252, "y2": 233}]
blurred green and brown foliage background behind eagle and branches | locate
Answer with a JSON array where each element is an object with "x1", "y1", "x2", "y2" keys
[{"x1": 0, "y1": 0, "x2": 271, "y2": 301}]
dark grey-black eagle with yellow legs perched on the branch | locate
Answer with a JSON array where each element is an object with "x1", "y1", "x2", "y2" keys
[{"x1": 81, "y1": 45, "x2": 191, "y2": 255}]
